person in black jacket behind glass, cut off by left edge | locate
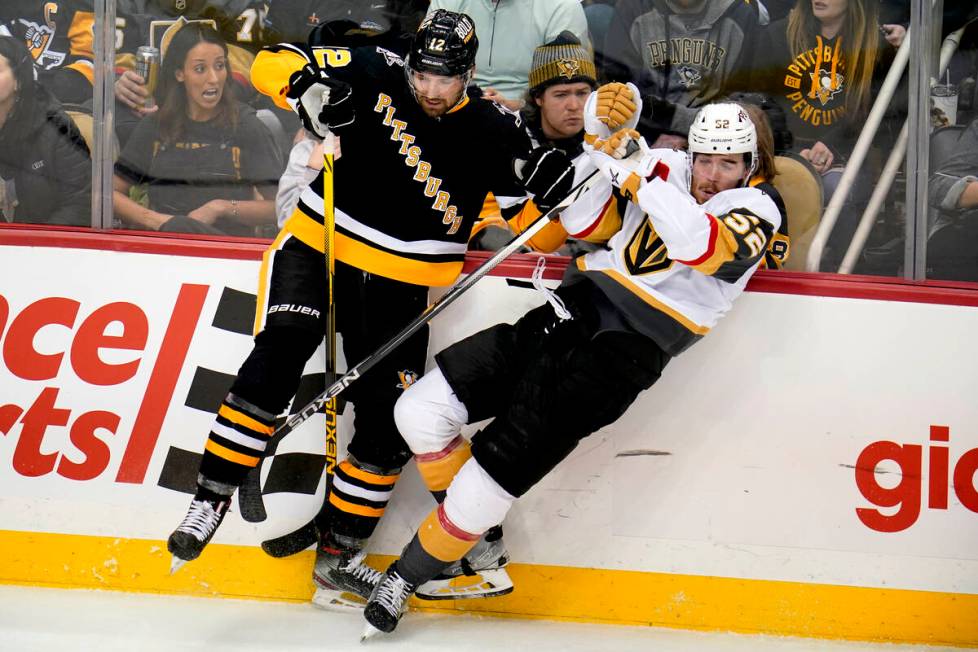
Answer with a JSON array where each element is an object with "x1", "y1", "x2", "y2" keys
[{"x1": 0, "y1": 36, "x2": 92, "y2": 226}]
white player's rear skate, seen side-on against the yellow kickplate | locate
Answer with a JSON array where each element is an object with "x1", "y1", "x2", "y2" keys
[{"x1": 417, "y1": 525, "x2": 513, "y2": 600}]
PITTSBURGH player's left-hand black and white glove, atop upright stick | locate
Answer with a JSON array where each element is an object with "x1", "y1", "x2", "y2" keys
[{"x1": 285, "y1": 63, "x2": 355, "y2": 138}]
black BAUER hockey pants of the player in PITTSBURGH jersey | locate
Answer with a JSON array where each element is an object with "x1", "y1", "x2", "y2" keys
[{"x1": 231, "y1": 239, "x2": 428, "y2": 469}]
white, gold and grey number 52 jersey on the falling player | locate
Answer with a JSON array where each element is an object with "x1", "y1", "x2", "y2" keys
[{"x1": 560, "y1": 149, "x2": 781, "y2": 355}]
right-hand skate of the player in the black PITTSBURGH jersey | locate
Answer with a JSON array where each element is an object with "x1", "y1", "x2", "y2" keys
[{"x1": 312, "y1": 535, "x2": 383, "y2": 610}]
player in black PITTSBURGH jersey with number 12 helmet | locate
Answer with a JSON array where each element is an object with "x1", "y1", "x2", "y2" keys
[{"x1": 168, "y1": 11, "x2": 573, "y2": 612}]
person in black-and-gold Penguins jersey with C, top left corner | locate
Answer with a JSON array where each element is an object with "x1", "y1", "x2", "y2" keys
[{"x1": 0, "y1": 0, "x2": 95, "y2": 104}]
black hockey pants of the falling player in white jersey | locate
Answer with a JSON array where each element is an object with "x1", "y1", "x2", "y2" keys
[{"x1": 435, "y1": 281, "x2": 670, "y2": 497}]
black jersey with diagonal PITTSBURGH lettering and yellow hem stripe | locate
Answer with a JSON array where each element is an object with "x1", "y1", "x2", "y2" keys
[{"x1": 251, "y1": 45, "x2": 530, "y2": 285}]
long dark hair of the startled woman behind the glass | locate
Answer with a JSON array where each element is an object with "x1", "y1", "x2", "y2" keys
[{"x1": 157, "y1": 22, "x2": 238, "y2": 143}]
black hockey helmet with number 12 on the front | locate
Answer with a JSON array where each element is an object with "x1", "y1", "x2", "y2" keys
[{"x1": 408, "y1": 9, "x2": 479, "y2": 76}]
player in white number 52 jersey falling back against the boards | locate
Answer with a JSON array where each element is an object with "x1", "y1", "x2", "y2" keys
[{"x1": 364, "y1": 97, "x2": 782, "y2": 636}]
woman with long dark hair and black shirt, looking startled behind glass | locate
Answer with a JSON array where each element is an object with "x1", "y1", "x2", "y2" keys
[{"x1": 113, "y1": 23, "x2": 283, "y2": 236}]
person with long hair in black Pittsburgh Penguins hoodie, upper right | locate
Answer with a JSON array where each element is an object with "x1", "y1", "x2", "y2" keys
[{"x1": 751, "y1": 0, "x2": 893, "y2": 183}]
